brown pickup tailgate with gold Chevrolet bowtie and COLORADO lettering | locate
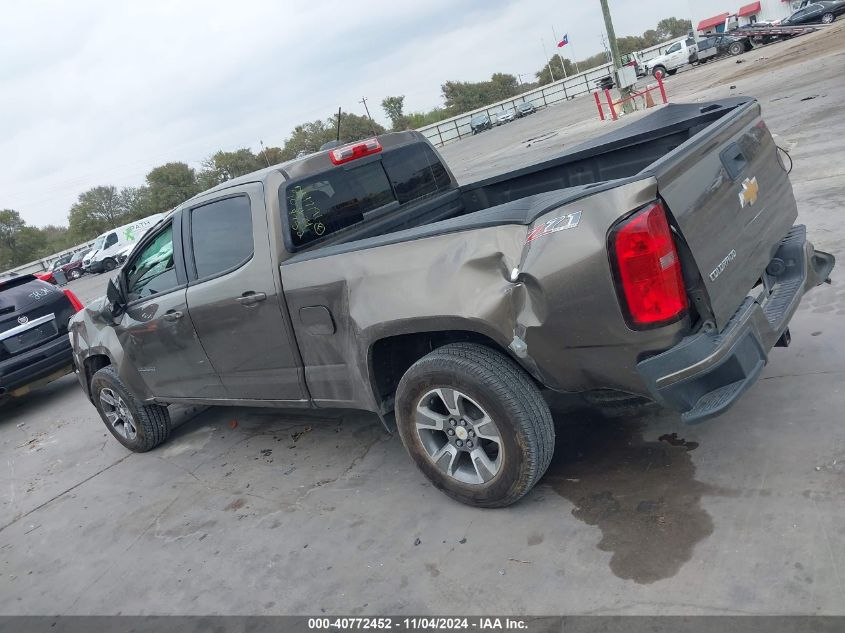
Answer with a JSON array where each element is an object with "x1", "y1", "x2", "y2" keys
[{"x1": 649, "y1": 101, "x2": 798, "y2": 330}]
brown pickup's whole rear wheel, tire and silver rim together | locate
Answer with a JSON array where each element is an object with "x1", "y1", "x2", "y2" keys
[{"x1": 396, "y1": 343, "x2": 555, "y2": 508}]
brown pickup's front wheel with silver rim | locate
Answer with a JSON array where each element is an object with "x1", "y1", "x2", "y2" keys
[{"x1": 91, "y1": 366, "x2": 170, "y2": 453}]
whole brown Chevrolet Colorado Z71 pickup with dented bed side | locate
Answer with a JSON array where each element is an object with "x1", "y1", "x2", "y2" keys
[{"x1": 70, "y1": 102, "x2": 834, "y2": 507}]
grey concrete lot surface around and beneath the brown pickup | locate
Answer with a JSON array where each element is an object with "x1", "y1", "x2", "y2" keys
[{"x1": 0, "y1": 22, "x2": 845, "y2": 614}]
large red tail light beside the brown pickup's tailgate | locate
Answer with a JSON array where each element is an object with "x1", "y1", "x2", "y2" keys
[{"x1": 610, "y1": 202, "x2": 689, "y2": 329}]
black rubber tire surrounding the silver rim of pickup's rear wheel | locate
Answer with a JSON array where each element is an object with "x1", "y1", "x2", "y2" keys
[{"x1": 396, "y1": 343, "x2": 555, "y2": 508}]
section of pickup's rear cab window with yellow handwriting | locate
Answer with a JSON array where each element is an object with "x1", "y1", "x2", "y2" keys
[{"x1": 282, "y1": 161, "x2": 396, "y2": 248}]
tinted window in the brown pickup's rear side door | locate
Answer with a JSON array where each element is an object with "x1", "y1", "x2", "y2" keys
[{"x1": 191, "y1": 196, "x2": 254, "y2": 279}]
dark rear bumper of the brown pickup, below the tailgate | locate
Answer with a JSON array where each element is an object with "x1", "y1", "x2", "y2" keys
[{"x1": 637, "y1": 225, "x2": 835, "y2": 423}]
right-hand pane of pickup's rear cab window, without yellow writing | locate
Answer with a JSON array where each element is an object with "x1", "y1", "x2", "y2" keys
[{"x1": 382, "y1": 143, "x2": 451, "y2": 204}]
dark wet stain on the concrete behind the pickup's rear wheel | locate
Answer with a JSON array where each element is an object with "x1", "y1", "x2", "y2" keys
[{"x1": 544, "y1": 410, "x2": 735, "y2": 584}]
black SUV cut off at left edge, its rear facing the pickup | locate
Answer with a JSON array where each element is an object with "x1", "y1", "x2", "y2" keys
[{"x1": 0, "y1": 275, "x2": 82, "y2": 397}]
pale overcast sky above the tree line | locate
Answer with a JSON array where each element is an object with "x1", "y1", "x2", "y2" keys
[{"x1": 0, "y1": 0, "x2": 741, "y2": 225}]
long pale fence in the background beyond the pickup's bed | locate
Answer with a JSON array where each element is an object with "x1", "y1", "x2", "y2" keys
[{"x1": 417, "y1": 36, "x2": 686, "y2": 147}]
